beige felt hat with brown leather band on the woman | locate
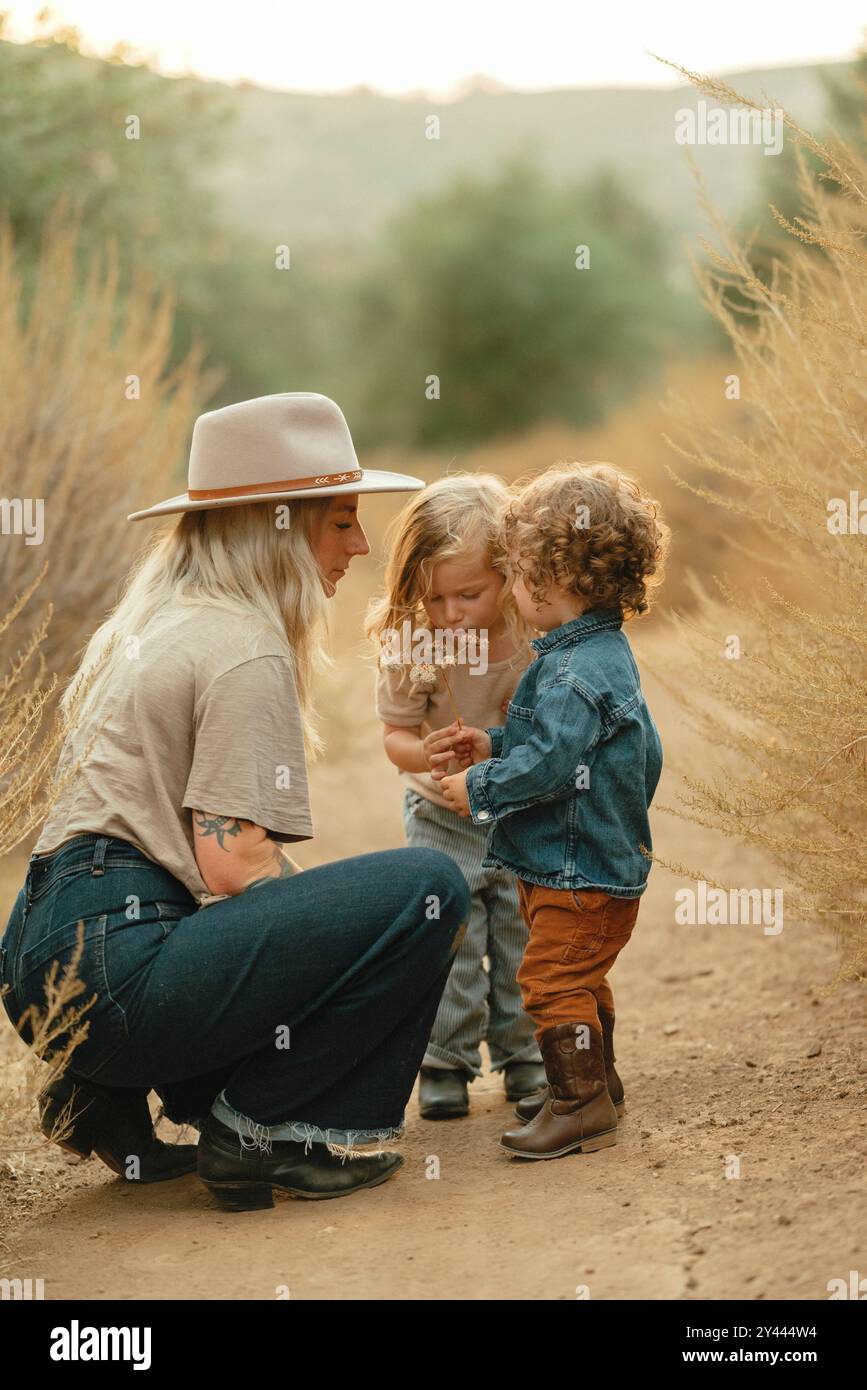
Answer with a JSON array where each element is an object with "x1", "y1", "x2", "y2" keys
[{"x1": 126, "y1": 391, "x2": 424, "y2": 521}]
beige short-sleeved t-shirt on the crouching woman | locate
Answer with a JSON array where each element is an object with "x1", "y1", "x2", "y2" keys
[{"x1": 33, "y1": 602, "x2": 313, "y2": 906}]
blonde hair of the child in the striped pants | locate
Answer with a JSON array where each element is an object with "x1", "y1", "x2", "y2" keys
[{"x1": 364, "y1": 473, "x2": 535, "y2": 648}]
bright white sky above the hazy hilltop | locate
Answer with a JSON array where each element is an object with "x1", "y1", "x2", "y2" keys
[{"x1": 6, "y1": 0, "x2": 867, "y2": 97}]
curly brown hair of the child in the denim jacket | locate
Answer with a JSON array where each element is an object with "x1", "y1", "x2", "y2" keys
[{"x1": 503, "y1": 463, "x2": 671, "y2": 620}]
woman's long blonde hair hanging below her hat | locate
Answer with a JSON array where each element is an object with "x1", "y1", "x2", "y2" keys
[{"x1": 61, "y1": 498, "x2": 333, "y2": 759}]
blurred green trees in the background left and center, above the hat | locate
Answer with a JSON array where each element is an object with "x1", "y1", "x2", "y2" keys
[{"x1": 0, "y1": 17, "x2": 720, "y2": 448}]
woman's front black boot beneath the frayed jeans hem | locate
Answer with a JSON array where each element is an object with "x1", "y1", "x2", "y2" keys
[{"x1": 199, "y1": 1115, "x2": 403, "y2": 1212}]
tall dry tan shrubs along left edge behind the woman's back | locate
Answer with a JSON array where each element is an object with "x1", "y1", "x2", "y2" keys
[{"x1": 0, "y1": 199, "x2": 218, "y2": 1184}]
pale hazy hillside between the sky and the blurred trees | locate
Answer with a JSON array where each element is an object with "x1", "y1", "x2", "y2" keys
[{"x1": 194, "y1": 64, "x2": 850, "y2": 242}]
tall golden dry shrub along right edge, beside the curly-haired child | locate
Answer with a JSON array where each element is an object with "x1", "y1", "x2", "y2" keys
[{"x1": 647, "y1": 59, "x2": 867, "y2": 988}]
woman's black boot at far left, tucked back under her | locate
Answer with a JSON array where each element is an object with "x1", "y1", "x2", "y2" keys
[{"x1": 39, "y1": 1073, "x2": 196, "y2": 1183}]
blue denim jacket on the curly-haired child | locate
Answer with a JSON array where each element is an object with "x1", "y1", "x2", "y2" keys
[{"x1": 467, "y1": 607, "x2": 663, "y2": 898}]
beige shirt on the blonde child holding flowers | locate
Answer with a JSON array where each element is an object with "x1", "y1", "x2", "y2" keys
[{"x1": 375, "y1": 645, "x2": 536, "y2": 808}]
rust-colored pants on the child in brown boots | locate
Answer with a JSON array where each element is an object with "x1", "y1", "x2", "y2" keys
[{"x1": 517, "y1": 878, "x2": 641, "y2": 1041}]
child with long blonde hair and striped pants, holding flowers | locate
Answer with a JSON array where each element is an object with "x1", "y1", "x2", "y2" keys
[{"x1": 367, "y1": 474, "x2": 545, "y2": 1119}]
